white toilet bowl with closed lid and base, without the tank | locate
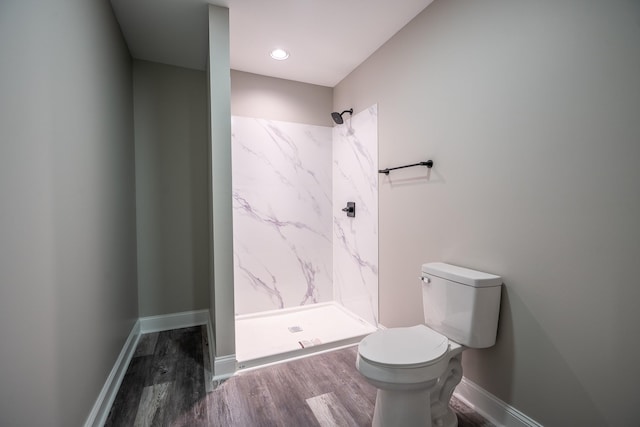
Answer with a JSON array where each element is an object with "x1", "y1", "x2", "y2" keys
[{"x1": 356, "y1": 325, "x2": 463, "y2": 427}]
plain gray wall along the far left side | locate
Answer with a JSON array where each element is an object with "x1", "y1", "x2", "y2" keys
[{"x1": 0, "y1": 0, "x2": 138, "y2": 426}]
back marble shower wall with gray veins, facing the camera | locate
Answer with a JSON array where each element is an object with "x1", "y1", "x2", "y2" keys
[{"x1": 231, "y1": 117, "x2": 333, "y2": 314}]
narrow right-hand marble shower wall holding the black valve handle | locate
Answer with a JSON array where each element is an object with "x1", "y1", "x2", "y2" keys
[{"x1": 333, "y1": 105, "x2": 378, "y2": 326}]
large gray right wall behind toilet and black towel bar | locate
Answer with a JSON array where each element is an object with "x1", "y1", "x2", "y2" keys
[{"x1": 334, "y1": 0, "x2": 640, "y2": 426}]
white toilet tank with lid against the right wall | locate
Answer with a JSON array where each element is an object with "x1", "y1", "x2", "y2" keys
[{"x1": 422, "y1": 262, "x2": 502, "y2": 348}]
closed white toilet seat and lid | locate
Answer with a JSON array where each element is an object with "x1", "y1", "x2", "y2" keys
[{"x1": 358, "y1": 325, "x2": 449, "y2": 368}]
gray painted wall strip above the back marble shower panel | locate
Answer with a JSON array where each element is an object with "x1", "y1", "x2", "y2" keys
[{"x1": 231, "y1": 70, "x2": 332, "y2": 126}]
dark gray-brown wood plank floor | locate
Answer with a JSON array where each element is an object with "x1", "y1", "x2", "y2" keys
[{"x1": 105, "y1": 326, "x2": 492, "y2": 427}]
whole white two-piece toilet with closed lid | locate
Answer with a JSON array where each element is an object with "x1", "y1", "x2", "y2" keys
[{"x1": 356, "y1": 262, "x2": 502, "y2": 427}]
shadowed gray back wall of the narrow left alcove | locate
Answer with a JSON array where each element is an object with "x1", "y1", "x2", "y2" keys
[{"x1": 133, "y1": 60, "x2": 209, "y2": 316}]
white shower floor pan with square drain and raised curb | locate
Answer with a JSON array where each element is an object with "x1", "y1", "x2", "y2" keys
[{"x1": 236, "y1": 302, "x2": 376, "y2": 369}]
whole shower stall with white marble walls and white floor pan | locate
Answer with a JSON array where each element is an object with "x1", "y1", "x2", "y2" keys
[{"x1": 231, "y1": 105, "x2": 378, "y2": 369}]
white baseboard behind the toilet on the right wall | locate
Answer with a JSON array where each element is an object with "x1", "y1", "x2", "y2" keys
[{"x1": 454, "y1": 377, "x2": 543, "y2": 427}]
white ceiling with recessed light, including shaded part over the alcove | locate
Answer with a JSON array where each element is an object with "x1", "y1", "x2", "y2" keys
[{"x1": 111, "y1": 0, "x2": 433, "y2": 87}]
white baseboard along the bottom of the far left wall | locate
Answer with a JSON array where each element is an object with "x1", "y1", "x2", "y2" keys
[{"x1": 84, "y1": 320, "x2": 140, "y2": 427}]
